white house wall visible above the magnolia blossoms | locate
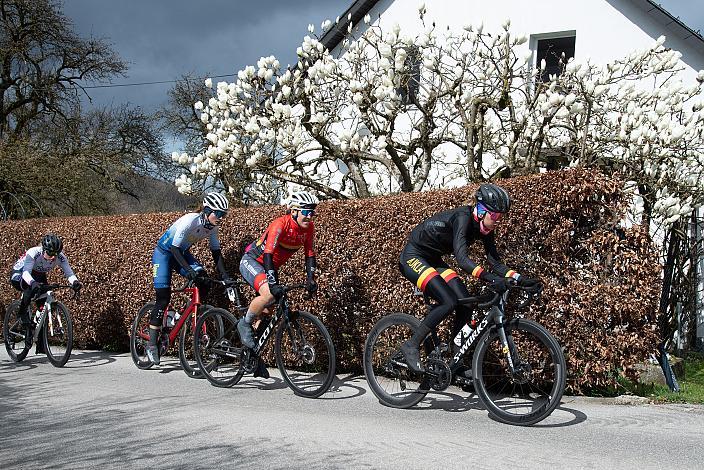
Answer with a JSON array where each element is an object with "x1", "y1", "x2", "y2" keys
[{"x1": 358, "y1": 0, "x2": 704, "y2": 81}]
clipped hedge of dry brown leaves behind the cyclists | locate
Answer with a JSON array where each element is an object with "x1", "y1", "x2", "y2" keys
[{"x1": 0, "y1": 170, "x2": 661, "y2": 393}]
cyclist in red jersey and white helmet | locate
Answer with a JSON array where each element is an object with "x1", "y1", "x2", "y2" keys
[{"x1": 237, "y1": 191, "x2": 319, "y2": 378}]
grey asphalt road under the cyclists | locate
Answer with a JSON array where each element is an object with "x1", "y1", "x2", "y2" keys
[{"x1": 0, "y1": 348, "x2": 704, "y2": 470}]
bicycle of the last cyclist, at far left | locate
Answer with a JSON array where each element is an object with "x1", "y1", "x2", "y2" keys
[{"x1": 2, "y1": 284, "x2": 78, "y2": 367}]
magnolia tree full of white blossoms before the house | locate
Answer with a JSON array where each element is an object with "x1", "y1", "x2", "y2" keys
[{"x1": 174, "y1": 6, "x2": 704, "y2": 228}]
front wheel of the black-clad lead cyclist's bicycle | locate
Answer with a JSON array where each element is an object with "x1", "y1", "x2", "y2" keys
[{"x1": 472, "y1": 319, "x2": 566, "y2": 426}]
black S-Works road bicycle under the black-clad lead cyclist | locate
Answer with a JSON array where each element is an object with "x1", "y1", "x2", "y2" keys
[{"x1": 364, "y1": 285, "x2": 566, "y2": 426}]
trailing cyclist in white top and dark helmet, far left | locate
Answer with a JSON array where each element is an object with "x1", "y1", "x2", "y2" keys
[{"x1": 10, "y1": 234, "x2": 83, "y2": 347}]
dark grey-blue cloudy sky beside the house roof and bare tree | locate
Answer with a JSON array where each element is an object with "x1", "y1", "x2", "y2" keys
[{"x1": 64, "y1": 0, "x2": 704, "y2": 111}]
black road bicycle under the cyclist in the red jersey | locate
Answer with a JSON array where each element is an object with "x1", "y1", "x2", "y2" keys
[{"x1": 194, "y1": 285, "x2": 335, "y2": 398}]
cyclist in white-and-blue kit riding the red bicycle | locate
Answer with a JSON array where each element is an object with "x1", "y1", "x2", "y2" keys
[{"x1": 147, "y1": 192, "x2": 230, "y2": 365}]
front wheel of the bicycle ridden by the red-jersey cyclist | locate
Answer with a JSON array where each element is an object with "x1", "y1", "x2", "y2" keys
[{"x1": 274, "y1": 311, "x2": 335, "y2": 398}]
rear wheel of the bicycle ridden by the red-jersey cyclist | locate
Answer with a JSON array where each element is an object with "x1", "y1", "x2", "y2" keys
[{"x1": 193, "y1": 308, "x2": 244, "y2": 387}]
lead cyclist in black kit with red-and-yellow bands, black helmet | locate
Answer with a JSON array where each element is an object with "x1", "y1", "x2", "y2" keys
[{"x1": 399, "y1": 184, "x2": 537, "y2": 372}]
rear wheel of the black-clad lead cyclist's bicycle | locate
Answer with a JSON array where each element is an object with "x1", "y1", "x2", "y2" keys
[{"x1": 363, "y1": 313, "x2": 430, "y2": 408}]
